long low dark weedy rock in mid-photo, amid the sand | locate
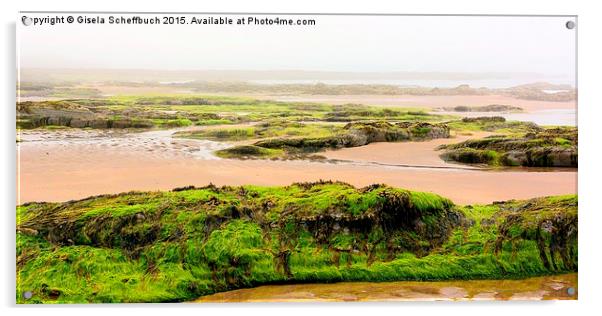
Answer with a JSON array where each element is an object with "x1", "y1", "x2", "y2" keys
[{"x1": 217, "y1": 121, "x2": 449, "y2": 158}]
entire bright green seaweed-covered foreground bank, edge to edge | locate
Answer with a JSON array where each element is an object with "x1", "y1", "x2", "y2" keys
[{"x1": 16, "y1": 182, "x2": 577, "y2": 303}]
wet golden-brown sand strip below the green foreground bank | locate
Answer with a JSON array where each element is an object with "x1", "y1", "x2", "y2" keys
[{"x1": 195, "y1": 273, "x2": 578, "y2": 303}]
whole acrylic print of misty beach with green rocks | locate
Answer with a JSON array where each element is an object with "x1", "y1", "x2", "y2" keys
[{"x1": 16, "y1": 12, "x2": 578, "y2": 304}]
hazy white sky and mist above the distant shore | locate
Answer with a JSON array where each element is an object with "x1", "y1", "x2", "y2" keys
[{"x1": 17, "y1": 14, "x2": 576, "y2": 86}]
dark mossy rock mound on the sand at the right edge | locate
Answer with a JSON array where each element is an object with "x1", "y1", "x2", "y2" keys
[{"x1": 440, "y1": 127, "x2": 578, "y2": 168}]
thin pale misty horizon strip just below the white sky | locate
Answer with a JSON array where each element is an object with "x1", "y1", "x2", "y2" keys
[{"x1": 20, "y1": 68, "x2": 574, "y2": 88}]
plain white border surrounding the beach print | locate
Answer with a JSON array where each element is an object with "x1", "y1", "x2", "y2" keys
[{"x1": 0, "y1": 0, "x2": 602, "y2": 316}]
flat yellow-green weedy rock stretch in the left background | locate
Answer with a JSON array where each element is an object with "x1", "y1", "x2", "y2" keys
[{"x1": 17, "y1": 95, "x2": 451, "y2": 131}]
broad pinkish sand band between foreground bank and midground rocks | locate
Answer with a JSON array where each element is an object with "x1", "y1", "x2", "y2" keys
[{"x1": 17, "y1": 131, "x2": 577, "y2": 204}]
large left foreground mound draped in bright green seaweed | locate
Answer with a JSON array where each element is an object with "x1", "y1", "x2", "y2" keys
[{"x1": 17, "y1": 181, "x2": 464, "y2": 302}]
